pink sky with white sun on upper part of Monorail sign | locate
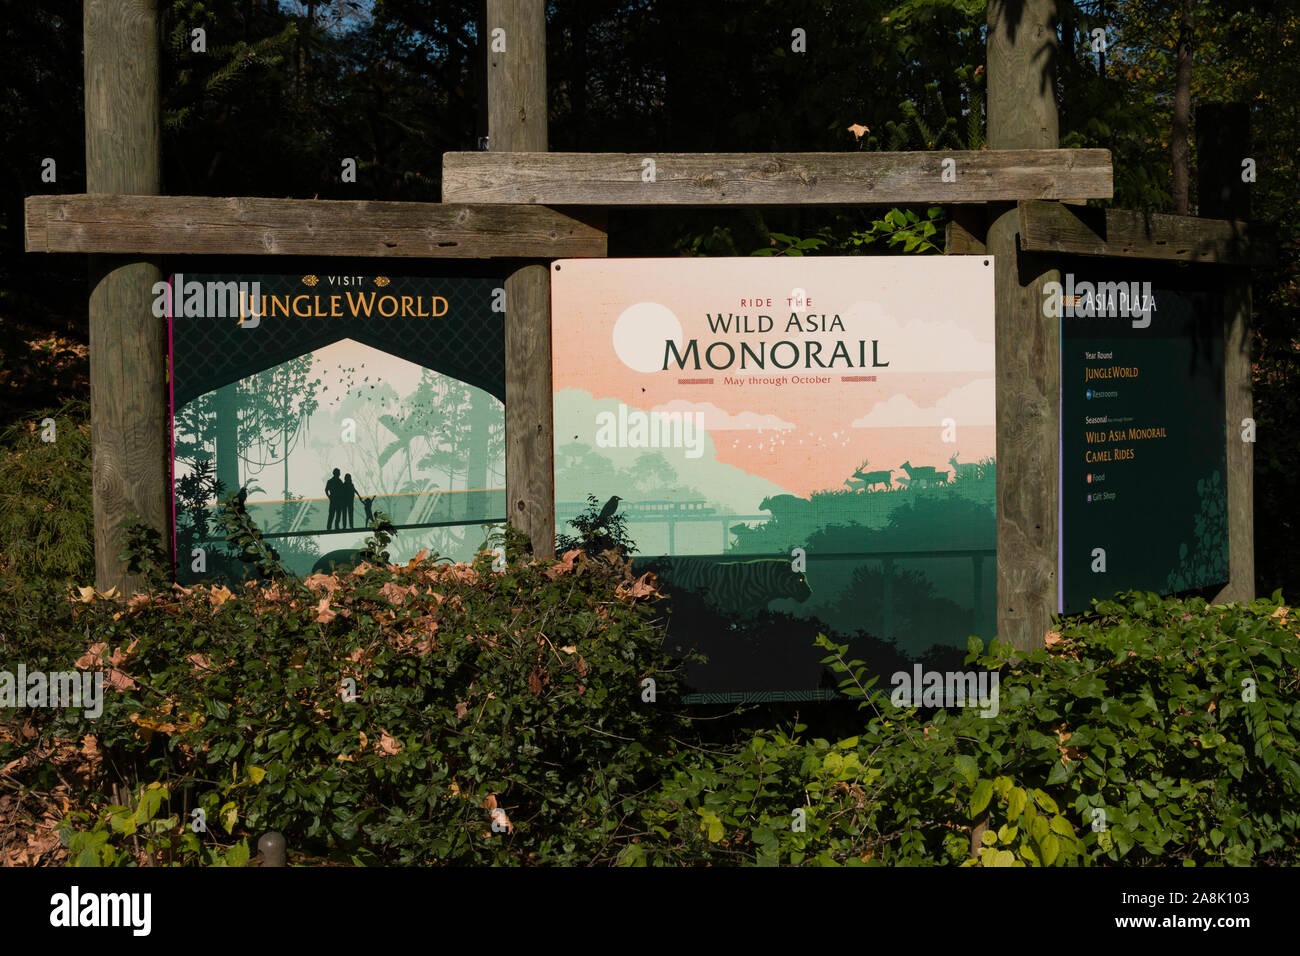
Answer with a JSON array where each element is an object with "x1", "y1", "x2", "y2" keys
[{"x1": 551, "y1": 256, "x2": 996, "y2": 497}]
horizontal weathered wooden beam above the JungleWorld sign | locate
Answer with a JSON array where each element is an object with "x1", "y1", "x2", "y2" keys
[{"x1": 26, "y1": 194, "x2": 606, "y2": 259}]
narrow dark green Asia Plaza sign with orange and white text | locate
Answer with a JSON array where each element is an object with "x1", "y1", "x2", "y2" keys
[{"x1": 1048, "y1": 260, "x2": 1229, "y2": 613}]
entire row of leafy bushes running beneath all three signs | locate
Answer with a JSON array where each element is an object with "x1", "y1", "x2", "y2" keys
[{"x1": 0, "y1": 515, "x2": 1300, "y2": 866}]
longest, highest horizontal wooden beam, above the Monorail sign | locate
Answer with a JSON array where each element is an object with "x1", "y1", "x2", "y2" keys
[{"x1": 442, "y1": 150, "x2": 1112, "y2": 206}]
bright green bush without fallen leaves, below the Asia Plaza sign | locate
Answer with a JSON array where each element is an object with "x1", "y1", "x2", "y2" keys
[{"x1": 620, "y1": 593, "x2": 1300, "y2": 866}]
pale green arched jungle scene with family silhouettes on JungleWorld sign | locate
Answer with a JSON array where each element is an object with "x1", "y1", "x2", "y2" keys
[{"x1": 174, "y1": 339, "x2": 506, "y2": 584}]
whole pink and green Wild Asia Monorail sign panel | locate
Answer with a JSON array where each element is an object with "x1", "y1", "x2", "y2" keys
[{"x1": 551, "y1": 256, "x2": 996, "y2": 700}]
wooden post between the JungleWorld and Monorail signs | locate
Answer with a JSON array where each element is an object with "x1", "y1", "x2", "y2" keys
[{"x1": 482, "y1": 0, "x2": 555, "y2": 557}]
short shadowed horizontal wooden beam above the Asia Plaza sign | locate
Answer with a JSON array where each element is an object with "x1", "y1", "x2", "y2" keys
[{"x1": 1019, "y1": 202, "x2": 1277, "y2": 265}]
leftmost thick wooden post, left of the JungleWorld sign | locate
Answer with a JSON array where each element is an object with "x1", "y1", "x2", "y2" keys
[{"x1": 85, "y1": 0, "x2": 172, "y2": 593}]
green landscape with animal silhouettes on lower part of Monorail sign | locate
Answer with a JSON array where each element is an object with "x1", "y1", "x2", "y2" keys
[{"x1": 555, "y1": 444, "x2": 997, "y2": 702}]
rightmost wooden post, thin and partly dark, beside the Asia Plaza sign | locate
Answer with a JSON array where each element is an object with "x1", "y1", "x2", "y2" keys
[{"x1": 1196, "y1": 103, "x2": 1255, "y2": 602}]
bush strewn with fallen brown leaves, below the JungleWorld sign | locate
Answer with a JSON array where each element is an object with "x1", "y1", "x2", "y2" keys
[{"x1": 0, "y1": 553, "x2": 685, "y2": 864}]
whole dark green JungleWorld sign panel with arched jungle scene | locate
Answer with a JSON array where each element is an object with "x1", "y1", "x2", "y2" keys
[{"x1": 163, "y1": 264, "x2": 506, "y2": 581}]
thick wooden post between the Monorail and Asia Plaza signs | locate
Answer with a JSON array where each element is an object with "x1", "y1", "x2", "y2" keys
[{"x1": 987, "y1": 0, "x2": 1061, "y2": 649}]
